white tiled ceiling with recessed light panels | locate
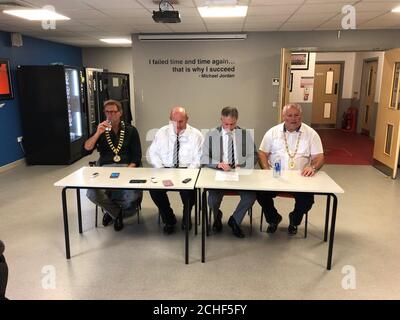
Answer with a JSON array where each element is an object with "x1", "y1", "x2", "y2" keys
[{"x1": 0, "y1": 0, "x2": 400, "y2": 47}]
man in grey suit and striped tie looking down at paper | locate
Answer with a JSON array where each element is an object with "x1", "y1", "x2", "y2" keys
[{"x1": 201, "y1": 107, "x2": 258, "y2": 238}]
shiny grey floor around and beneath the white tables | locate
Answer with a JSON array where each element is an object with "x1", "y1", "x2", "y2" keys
[{"x1": 0, "y1": 156, "x2": 400, "y2": 299}]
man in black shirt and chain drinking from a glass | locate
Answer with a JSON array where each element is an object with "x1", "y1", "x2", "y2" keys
[{"x1": 85, "y1": 100, "x2": 142, "y2": 231}]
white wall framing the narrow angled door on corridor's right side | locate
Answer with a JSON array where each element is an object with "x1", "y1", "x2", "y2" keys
[{"x1": 353, "y1": 51, "x2": 385, "y2": 103}]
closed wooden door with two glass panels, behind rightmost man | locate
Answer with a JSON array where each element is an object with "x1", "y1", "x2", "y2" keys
[{"x1": 311, "y1": 64, "x2": 341, "y2": 128}]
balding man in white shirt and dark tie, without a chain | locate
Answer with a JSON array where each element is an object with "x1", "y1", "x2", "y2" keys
[{"x1": 149, "y1": 107, "x2": 203, "y2": 234}]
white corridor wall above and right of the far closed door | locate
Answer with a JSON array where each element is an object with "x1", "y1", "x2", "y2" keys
[{"x1": 316, "y1": 52, "x2": 356, "y2": 99}]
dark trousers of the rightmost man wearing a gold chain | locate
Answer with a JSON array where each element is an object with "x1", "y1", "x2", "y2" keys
[{"x1": 257, "y1": 191, "x2": 314, "y2": 226}]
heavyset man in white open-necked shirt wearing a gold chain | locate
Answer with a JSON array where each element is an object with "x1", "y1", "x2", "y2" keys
[{"x1": 257, "y1": 104, "x2": 324, "y2": 235}]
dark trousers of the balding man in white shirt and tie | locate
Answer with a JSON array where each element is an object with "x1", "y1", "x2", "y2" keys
[{"x1": 150, "y1": 190, "x2": 196, "y2": 225}]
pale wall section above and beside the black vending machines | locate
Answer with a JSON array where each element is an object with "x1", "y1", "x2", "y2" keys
[{"x1": 82, "y1": 48, "x2": 137, "y2": 124}]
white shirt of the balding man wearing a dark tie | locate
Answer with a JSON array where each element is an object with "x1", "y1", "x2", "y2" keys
[{"x1": 148, "y1": 124, "x2": 203, "y2": 168}]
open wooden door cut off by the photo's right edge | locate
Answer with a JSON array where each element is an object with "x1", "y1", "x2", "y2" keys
[{"x1": 374, "y1": 49, "x2": 400, "y2": 179}]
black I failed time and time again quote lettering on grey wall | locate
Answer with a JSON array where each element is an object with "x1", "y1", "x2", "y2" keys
[{"x1": 148, "y1": 58, "x2": 236, "y2": 79}]
